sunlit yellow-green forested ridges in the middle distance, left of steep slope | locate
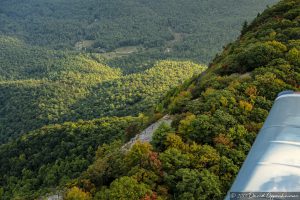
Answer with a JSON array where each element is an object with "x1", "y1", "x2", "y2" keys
[{"x1": 0, "y1": 37, "x2": 205, "y2": 143}]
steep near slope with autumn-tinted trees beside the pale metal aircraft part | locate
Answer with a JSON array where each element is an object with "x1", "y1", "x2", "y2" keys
[{"x1": 54, "y1": 0, "x2": 300, "y2": 200}]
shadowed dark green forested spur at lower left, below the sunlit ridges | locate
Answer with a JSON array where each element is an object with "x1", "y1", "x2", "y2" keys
[{"x1": 0, "y1": 115, "x2": 147, "y2": 199}]
